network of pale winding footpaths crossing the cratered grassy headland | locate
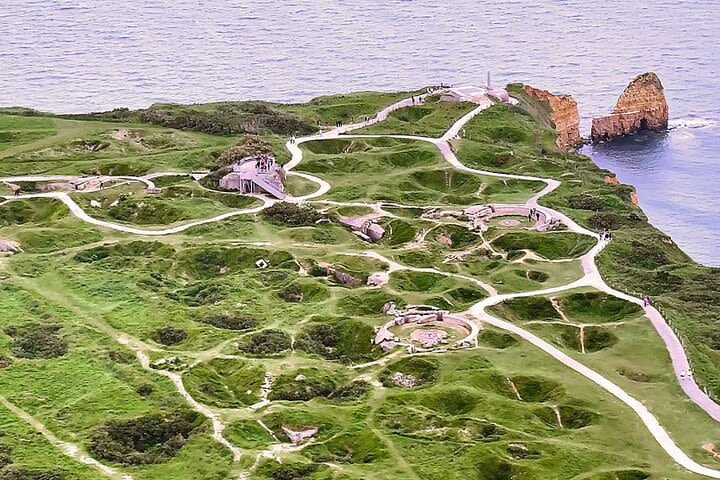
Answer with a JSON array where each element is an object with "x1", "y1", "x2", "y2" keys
[{"x1": 0, "y1": 93, "x2": 720, "y2": 479}]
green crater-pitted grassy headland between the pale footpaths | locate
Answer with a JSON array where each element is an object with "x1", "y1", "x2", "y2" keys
[{"x1": 0, "y1": 87, "x2": 720, "y2": 480}]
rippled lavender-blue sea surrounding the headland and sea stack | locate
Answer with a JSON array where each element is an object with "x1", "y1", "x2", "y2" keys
[{"x1": 0, "y1": 0, "x2": 720, "y2": 266}]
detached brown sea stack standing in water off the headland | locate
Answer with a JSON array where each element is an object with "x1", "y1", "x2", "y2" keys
[{"x1": 590, "y1": 72, "x2": 668, "y2": 143}]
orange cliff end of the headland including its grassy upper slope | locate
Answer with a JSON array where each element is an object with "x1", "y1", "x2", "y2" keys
[{"x1": 508, "y1": 84, "x2": 583, "y2": 150}]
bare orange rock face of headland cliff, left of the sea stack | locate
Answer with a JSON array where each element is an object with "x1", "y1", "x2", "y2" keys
[{"x1": 523, "y1": 85, "x2": 583, "y2": 149}]
